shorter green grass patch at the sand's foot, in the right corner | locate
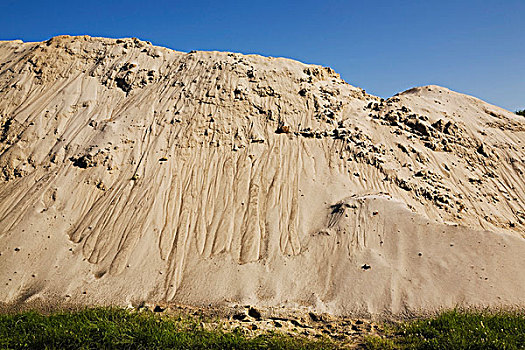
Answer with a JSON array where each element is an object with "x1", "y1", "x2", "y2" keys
[{"x1": 367, "y1": 310, "x2": 525, "y2": 349}]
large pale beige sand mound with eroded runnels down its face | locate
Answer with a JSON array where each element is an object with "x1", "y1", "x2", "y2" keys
[{"x1": 0, "y1": 37, "x2": 525, "y2": 315}]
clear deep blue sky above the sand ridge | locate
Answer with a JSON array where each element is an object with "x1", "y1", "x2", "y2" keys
[{"x1": 0, "y1": 0, "x2": 525, "y2": 111}]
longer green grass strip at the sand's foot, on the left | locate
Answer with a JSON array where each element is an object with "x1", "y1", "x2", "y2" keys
[{"x1": 0, "y1": 308, "x2": 335, "y2": 349}]
